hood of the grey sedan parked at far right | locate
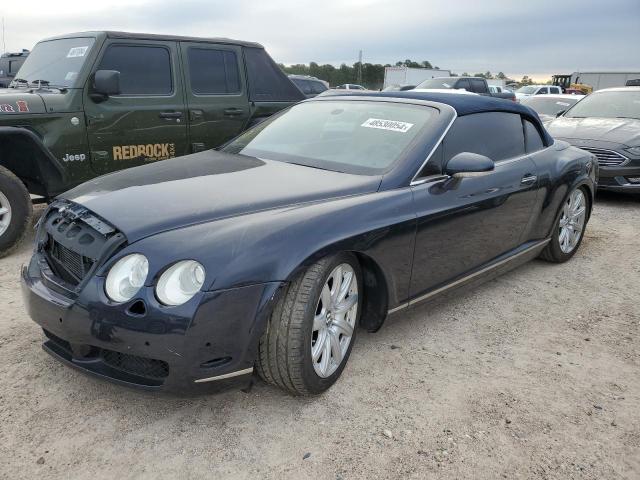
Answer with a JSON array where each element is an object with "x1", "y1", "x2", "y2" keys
[{"x1": 547, "y1": 117, "x2": 640, "y2": 147}]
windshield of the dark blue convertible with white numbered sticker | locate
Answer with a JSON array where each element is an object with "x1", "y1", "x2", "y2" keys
[{"x1": 222, "y1": 100, "x2": 438, "y2": 175}]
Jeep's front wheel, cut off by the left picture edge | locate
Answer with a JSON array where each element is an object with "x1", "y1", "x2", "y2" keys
[{"x1": 0, "y1": 166, "x2": 33, "y2": 258}]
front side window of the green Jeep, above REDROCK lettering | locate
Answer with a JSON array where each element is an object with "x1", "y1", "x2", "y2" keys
[{"x1": 98, "y1": 45, "x2": 173, "y2": 95}]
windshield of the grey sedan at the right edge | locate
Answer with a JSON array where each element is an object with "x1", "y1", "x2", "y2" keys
[{"x1": 564, "y1": 90, "x2": 640, "y2": 119}]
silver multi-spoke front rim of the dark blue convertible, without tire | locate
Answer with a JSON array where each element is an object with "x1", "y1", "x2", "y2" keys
[{"x1": 311, "y1": 263, "x2": 358, "y2": 378}]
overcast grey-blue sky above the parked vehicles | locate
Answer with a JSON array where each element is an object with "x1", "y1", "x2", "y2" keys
[{"x1": 0, "y1": 0, "x2": 640, "y2": 80}]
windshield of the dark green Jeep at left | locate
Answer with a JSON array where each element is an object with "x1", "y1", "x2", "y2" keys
[{"x1": 10, "y1": 37, "x2": 95, "y2": 87}]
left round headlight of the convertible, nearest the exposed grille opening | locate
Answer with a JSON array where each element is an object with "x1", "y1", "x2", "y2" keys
[{"x1": 105, "y1": 253, "x2": 149, "y2": 303}]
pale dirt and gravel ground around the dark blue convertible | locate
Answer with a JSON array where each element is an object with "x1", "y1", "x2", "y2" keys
[{"x1": 0, "y1": 195, "x2": 640, "y2": 480}]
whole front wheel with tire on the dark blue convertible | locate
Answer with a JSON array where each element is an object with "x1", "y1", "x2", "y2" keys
[{"x1": 256, "y1": 253, "x2": 362, "y2": 395}]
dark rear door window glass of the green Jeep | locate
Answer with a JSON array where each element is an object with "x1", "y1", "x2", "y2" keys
[{"x1": 188, "y1": 47, "x2": 240, "y2": 95}]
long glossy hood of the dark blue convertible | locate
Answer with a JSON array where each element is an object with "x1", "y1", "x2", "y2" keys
[{"x1": 59, "y1": 150, "x2": 381, "y2": 243}]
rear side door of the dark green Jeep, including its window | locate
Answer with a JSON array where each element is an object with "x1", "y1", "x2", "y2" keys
[{"x1": 180, "y1": 42, "x2": 250, "y2": 152}]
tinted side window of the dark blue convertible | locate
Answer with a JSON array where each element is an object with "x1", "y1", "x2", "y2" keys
[{"x1": 443, "y1": 112, "x2": 525, "y2": 165}]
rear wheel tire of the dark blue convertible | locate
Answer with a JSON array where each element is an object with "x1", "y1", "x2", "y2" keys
[{"x1": 540, "y1": 187, "x2": 591, "y2": 263}]
